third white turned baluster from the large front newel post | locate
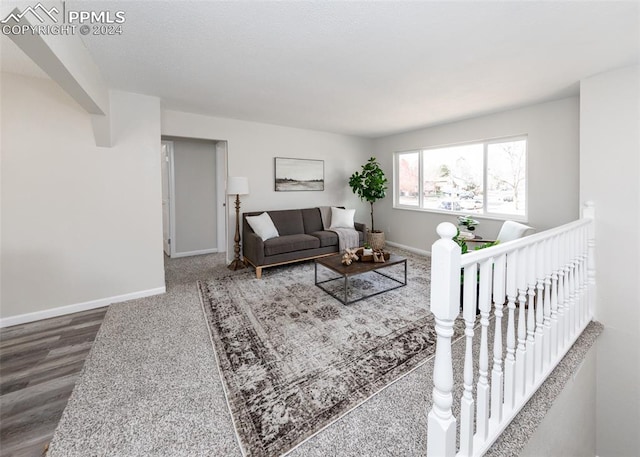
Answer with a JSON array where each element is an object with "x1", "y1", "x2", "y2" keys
[{"x1": 491, "y1": 254, "x2": 507, "y2": 424}]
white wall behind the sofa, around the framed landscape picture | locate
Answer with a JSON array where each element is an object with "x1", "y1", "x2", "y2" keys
[{"x1": 162, "y1": 110, "x2": 372, "y2": 252}]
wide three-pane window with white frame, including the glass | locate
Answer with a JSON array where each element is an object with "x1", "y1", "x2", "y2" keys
[{"x1": 394, "y1": 137, "x2": 527, "y2": 220}]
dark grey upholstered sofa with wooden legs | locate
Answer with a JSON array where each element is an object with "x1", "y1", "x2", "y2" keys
[{"x1": 242, "y1": 208, "x2": 366, "y2": 279}]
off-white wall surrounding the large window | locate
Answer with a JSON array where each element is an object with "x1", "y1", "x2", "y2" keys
[{"x1": 374, "y1": 97, "x2": 579, "y2": 251}]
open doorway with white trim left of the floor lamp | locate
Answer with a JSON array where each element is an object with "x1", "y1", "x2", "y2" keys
[{"x1": 161, "y1": 137, "x2": 227, "y2": 258}]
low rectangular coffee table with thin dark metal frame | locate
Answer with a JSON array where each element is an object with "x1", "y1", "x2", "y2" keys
[{"x1": 314, "y1": 254, "x2": 407, "y2": 305}]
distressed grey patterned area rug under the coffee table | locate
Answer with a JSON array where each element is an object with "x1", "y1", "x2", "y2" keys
[{"x1": 199, "y1": 255, "x2": 462, "y2": 457}]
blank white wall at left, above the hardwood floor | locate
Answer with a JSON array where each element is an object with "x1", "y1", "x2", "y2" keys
[{"x1": 0, "y1": 73, "x2": 164, "y2": 325}]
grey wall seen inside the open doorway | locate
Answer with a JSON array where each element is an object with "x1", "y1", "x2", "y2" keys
[{"x1": 171, "y1": 139, "x2": 217, "y2": 254}]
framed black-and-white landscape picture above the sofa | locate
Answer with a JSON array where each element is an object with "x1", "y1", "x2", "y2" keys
[{"x1": 275, "y1": 157, "x2": 324, "y2": 192}]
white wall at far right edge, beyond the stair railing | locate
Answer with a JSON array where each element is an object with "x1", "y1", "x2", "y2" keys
[{"x1": 580, "y1": 66, "x2": 640, "y2": 457}]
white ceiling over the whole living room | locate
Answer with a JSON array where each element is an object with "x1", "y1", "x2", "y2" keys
[{"x1": 3, "y1": 1, "x2": 640, "y2": 138}]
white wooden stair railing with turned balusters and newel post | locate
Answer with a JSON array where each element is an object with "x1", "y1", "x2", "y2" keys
[{"x1": 427, "y1": 203, "x2": 595, "y2": 457}]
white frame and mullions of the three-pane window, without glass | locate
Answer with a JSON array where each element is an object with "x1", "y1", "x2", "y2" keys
[{"x1": 393, "y1": 134, "x2": 530, "y2": 222}]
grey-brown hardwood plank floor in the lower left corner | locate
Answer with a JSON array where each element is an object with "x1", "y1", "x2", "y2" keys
[{"x1": 0, "y1": 307, "x2": 107, "y2": 457}]
